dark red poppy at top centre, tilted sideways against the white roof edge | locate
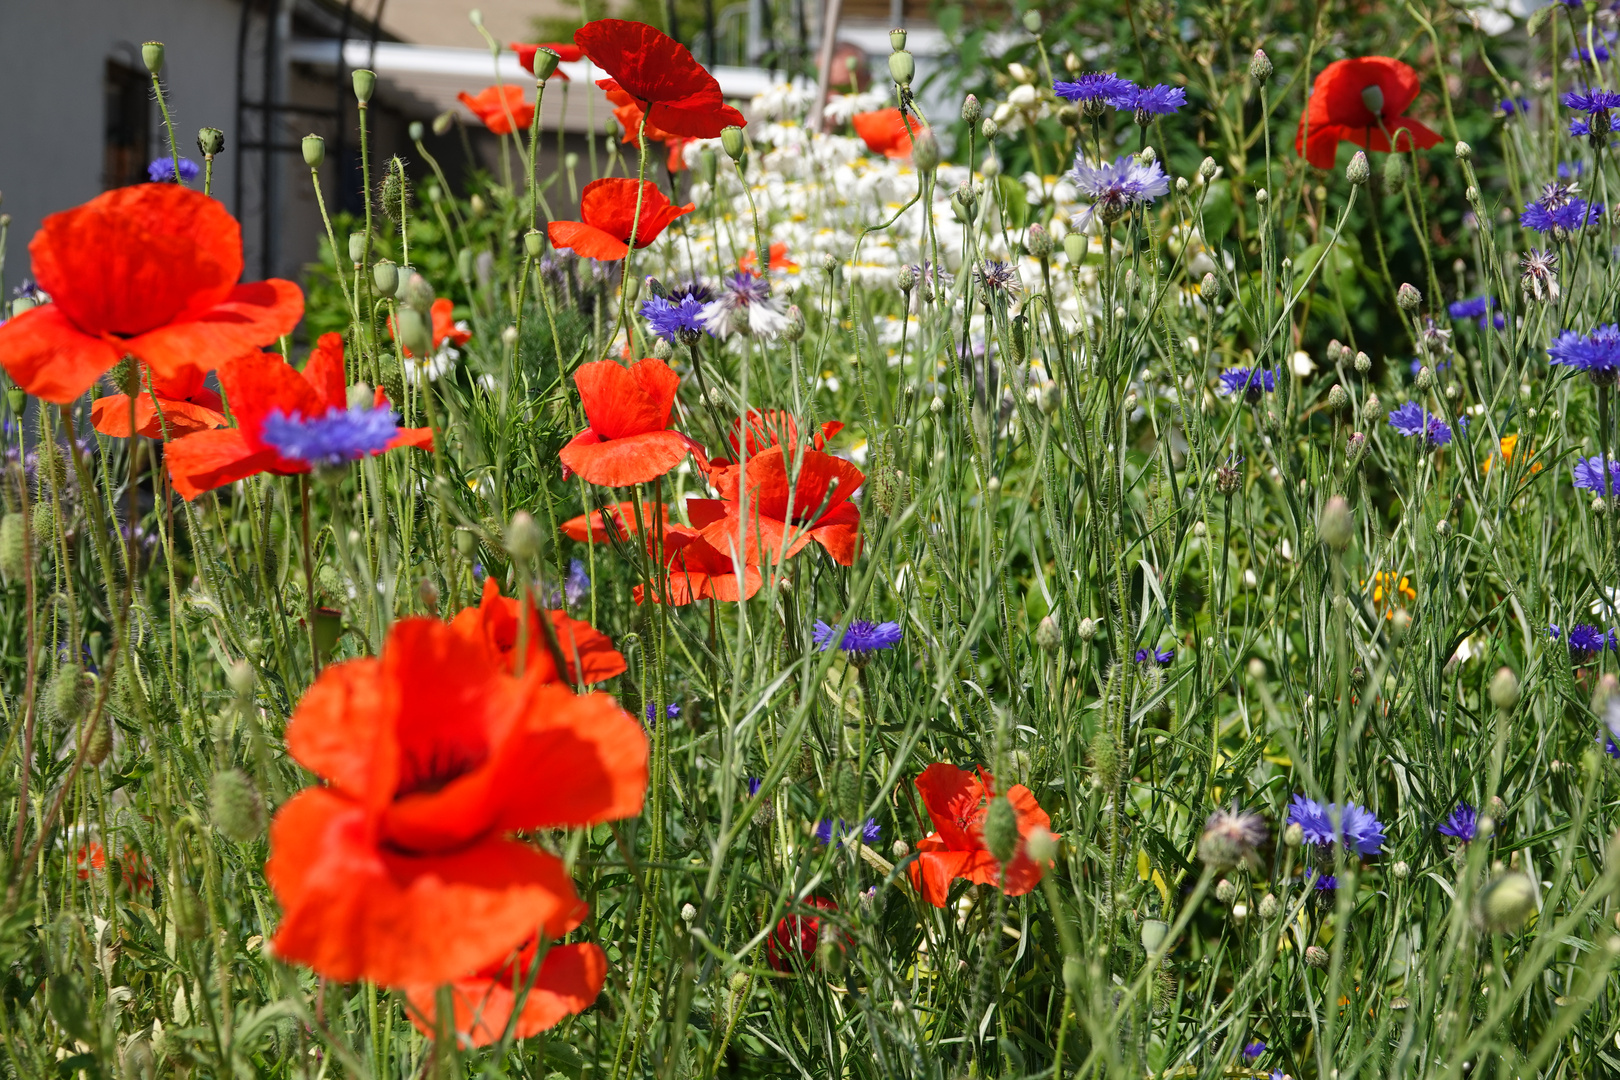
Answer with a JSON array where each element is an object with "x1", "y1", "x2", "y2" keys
[{"x1": 573, "y1": 19, "x2": 748, "y2": 139}]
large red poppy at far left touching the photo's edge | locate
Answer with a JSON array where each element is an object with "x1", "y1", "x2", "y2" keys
[{"x1": 0, "y1": 183, "x2": 303, "y2": 405}]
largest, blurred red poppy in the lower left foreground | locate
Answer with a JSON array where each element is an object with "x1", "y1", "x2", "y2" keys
[{"x1": 264, "y1": 619, "x2": 646, "y2": 986}]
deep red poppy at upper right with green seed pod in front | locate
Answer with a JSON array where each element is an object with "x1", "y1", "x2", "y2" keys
[{"x1": 1294, "y1": 57, "x2": 1440, "y2": 168}]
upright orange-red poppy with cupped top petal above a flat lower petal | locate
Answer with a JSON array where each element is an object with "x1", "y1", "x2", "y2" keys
[{"x1": 557, "y1": 359, "x2": 703, "y2": 487}]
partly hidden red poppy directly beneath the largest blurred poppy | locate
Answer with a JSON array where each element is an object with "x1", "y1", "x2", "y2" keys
[{"x1": 405, "y1": 939, "x2": 608, "y2": 1046}]
